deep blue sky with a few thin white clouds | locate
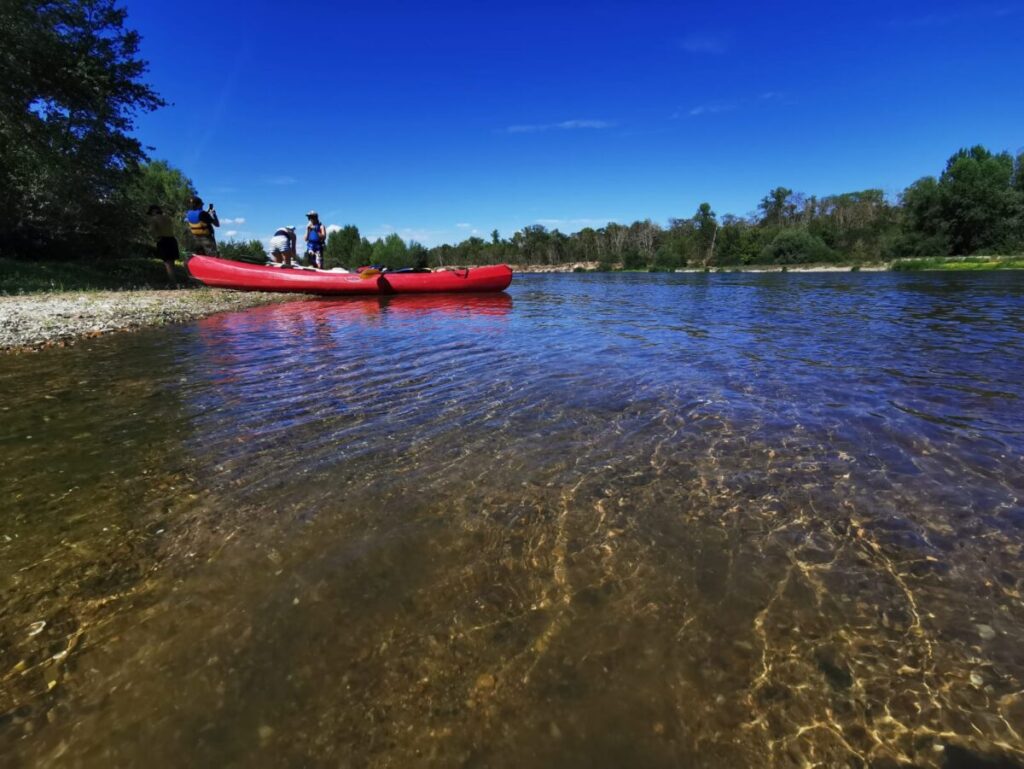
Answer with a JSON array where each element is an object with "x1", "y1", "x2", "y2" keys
[{"x1": 125, "y1": 0, "x2": 1024, "y2": 246}]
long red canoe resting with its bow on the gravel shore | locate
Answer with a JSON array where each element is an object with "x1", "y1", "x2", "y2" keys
[{"x1": 188, "y1": 256, "x2": 512, "y2": 294}]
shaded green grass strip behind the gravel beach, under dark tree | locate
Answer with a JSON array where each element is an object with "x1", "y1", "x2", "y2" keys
[{"x1": 0, "y1": 257, "x2": 189, "y2": 294}]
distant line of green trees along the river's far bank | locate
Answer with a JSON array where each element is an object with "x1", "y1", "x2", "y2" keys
[{"x1": 326, "y1": 146, "x2": 1024, "y2": 270}]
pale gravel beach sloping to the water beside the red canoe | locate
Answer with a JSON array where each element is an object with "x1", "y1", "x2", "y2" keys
[{"x1": 0, "y1": 289, "x2": 308, "y2": 351}]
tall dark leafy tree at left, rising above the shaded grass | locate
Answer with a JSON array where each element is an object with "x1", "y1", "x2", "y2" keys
[{"x1": 0, "y1": 0, "x2": 164, "y2": 255}]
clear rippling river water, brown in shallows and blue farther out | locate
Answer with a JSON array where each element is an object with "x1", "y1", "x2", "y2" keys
[{"x1": 0, "y1": 273, "x2": 1024, "y2": 769}]
